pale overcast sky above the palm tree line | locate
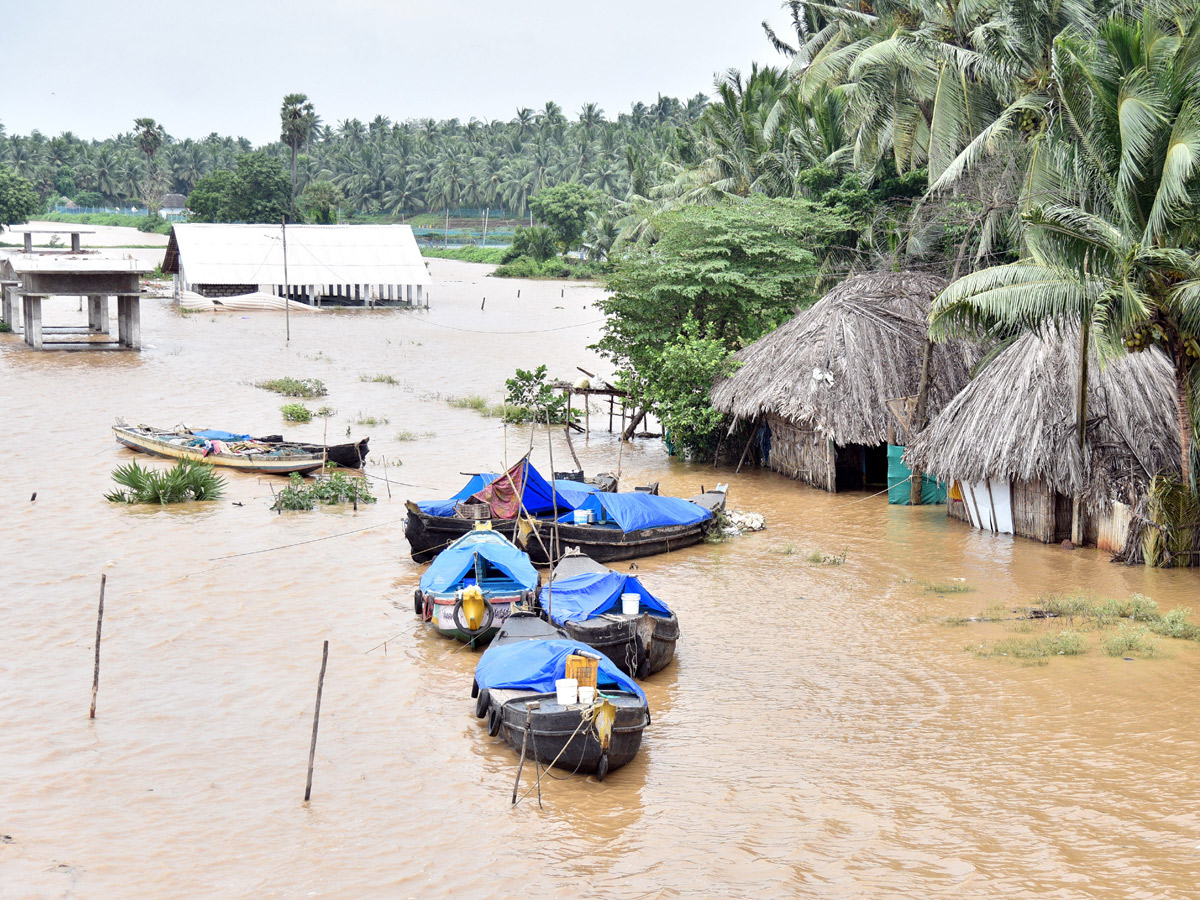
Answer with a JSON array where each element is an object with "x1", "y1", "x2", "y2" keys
[{"x1": 9, "y1": 0, "x2": 788, "y2": 145}]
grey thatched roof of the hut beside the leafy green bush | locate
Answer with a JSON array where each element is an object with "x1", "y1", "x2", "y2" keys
[{"x1": 713, "y1": 272, "x2": 972, "y2": 446}]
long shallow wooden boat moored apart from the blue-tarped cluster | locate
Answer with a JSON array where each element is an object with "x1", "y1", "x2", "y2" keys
[{"x1": 113, "y1": 422, "x2": 370, "y2": 475}]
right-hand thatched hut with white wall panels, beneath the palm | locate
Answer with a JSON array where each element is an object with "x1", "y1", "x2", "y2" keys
[{"x1": 905, "y1": 328, "x2": 1180, "y2": 551}]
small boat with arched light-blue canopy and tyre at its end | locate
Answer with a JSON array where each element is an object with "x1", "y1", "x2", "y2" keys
[{"x1": 413, "y1": 524, "x2": 541, "y2": 648}]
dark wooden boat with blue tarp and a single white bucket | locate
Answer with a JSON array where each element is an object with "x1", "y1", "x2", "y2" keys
[{"x1": 541, "y1": 552, "x2": 679, "y2": 678}]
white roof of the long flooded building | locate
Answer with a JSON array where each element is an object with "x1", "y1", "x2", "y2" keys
[{"x1": 163, "y1": 222, "x2": 432, "y2": 284}]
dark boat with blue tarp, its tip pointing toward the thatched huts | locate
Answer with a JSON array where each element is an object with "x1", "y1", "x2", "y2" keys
[{"x1": 524, "y1": 486, "x2": 726, "y2": 565}]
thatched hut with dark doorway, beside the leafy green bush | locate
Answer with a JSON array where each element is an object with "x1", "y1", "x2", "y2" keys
[{"x1": 713, "y1": 272, "x2": 971, "y2": 491}]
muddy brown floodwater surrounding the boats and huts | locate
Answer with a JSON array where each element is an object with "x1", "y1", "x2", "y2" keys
[{"x1": 0, "y1": 260, "x2": 1200, "y2": 900}]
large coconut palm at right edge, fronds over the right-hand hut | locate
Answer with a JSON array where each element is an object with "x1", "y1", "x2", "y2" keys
[{"x1": 932, "y1": 8, "x2": 1200, "y2": 485}]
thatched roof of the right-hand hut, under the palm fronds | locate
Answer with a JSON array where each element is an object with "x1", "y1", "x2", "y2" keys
[{"x1": 905, "y1": 328, "x2": 1180, "y2": 502}]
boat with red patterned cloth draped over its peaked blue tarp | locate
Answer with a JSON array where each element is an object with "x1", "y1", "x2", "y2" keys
[{"x1": 404, "y1": 457, "x2": 617, "y2": 563}]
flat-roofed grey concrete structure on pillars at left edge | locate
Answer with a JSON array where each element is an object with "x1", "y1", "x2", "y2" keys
[{"x1": 0, "y1": 252, "x2": 150, "y2": 350}]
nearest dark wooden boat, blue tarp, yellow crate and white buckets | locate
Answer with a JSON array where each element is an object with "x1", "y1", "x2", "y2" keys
[{"x1": 472, "y1": 612, "x2": 650, "y2": 781}]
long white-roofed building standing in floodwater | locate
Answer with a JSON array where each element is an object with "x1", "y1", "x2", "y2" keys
[{"x1": 162, "y1": 223, "x2": 432, "y2": 306}]
